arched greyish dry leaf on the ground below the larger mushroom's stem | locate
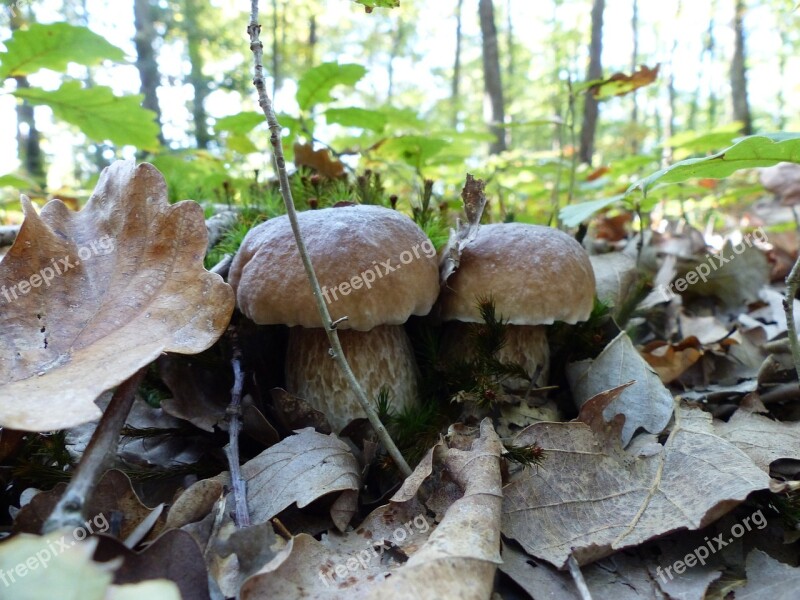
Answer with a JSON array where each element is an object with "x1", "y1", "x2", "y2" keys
[{"x1": 242, "y1": 428, "x2": 361, "y2": 530}]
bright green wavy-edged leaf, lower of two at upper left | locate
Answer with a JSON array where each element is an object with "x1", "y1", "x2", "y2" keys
[{"x1": 14, "y1": 81, "x2": 159, "y2": 150}]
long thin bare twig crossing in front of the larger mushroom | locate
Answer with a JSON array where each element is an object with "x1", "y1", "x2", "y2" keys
[{"x1": 247, "y1": 0, "x2": 411, "y2": 477}]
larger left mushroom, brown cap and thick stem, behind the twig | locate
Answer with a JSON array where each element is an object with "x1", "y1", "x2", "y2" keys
[{"x1": 229, "y1": 205, "x2": 439, "y2": 432}]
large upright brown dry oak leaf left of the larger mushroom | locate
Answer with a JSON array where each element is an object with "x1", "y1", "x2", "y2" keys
[{"x1": 0, "y1": 161, "x2": 234, "y2": 431}]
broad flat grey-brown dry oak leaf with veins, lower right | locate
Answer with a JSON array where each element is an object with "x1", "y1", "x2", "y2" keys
[{"x1": 503, "y1": 397, "x2": 769, "y2": 568}]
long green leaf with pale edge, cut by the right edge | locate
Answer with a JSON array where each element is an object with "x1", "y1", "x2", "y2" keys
[{"x1": 626, "y1": 133, "x2": 800, "y2": 194}]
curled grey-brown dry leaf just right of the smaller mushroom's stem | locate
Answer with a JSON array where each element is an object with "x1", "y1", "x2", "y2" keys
[{"x1": 567, "y1": 331, "x2": 673, "y2": 446}]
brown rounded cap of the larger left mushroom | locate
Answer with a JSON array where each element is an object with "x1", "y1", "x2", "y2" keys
[{"x1": 229, "y1": 205, "x2": 439, "y2": 331}]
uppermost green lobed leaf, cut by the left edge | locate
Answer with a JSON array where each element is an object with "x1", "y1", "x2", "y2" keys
[{"x1": 0, "y1": 23, "x2": 125, "y2": 81}]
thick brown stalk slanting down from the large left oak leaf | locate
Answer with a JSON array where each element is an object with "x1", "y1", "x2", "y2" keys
[{"x1": 42, "y1": 366, "x2": 147, "y2": 533}]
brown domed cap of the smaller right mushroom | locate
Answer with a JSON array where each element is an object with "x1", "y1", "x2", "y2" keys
[{"x1": 442, "y1": 223, "x2": 595, "y2": 325}]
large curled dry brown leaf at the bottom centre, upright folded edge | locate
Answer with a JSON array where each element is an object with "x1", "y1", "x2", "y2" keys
[{"x1": 241, "y1": 419, "x2": 502, "y2": 600}]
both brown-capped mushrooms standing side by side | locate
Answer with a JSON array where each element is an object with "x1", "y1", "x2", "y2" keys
[{"x1": 229, "y1": 205, "x2": 595, "y2": 432}]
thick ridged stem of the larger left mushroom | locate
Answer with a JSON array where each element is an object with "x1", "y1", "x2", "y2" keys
[{"x1": 286, "y1": 325, "x2": 419, "y2": 432}]
